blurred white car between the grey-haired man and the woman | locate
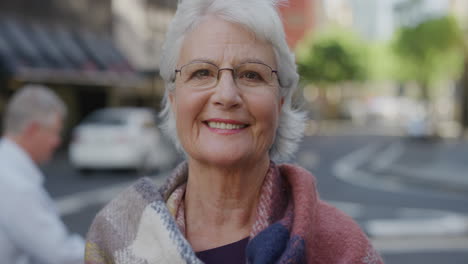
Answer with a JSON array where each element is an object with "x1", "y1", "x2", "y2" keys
[{"x1": 68, "y1": 107, "x2": 177, "y2": 170}]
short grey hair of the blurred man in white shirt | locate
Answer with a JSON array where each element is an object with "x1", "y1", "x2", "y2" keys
[{"x1": 3, "y1": 84, "x2": 67, "y2": 134}]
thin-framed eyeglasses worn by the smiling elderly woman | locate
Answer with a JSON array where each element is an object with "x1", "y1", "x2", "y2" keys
[{"x1": 174, "y1": 61, "x2": 279, "y2": 89}]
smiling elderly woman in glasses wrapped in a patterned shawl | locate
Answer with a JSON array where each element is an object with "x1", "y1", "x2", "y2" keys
[{"x1": 86, "y1": 0, "x2": 382, "y2": 264}]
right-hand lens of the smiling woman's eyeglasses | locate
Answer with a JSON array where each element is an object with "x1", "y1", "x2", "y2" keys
[{"x1": 236, "y1": 62, "x2": 273, "y2": 86}]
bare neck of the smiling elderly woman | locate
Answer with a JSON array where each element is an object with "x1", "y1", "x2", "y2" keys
[{"x1": 185, "y1": 157, "x2": 270, "y2": 251}]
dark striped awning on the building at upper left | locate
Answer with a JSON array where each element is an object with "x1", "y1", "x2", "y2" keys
[{"x1": 0, "y1": 19, "x2": 145, "y2": 86}]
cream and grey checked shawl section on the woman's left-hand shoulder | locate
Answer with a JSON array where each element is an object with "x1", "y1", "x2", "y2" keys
[{"x1": 85, "y1": 178, "x2": 194, "y2": 264}]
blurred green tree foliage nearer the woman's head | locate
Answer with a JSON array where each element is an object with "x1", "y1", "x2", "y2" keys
[{"x1": 297, "y1": 29, "x2": 367, "y2": 86}]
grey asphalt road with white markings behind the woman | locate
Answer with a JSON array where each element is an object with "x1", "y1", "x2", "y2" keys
[{"x1": 44, "y1": 124, "x2": 468, "y2": 264}]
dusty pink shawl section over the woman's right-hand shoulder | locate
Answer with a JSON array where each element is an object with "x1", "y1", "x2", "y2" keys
[{"x1": 278, "y1": 164, "x2": 383, "y2": 264}]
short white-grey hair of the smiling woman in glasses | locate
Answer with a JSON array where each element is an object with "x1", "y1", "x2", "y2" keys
[{"x1": 160, "y1": 0, "x2": 306, "y2": 162}]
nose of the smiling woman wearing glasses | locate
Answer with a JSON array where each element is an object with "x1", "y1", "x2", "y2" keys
[{"x1": 212, "y1": 69, "x2": 242, "y2": 109}]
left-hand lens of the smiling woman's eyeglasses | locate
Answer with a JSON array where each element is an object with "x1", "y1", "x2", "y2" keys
[{"x1": 180, "y1": 62, "x2": 218, "y2": 88}]
